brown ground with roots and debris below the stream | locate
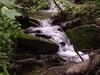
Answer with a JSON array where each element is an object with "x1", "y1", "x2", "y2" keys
[{"x1": 10, "y1": 50, "x2": 100, "y2": 75}]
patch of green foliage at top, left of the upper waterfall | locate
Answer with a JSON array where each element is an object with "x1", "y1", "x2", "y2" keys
[{"x1": 16, "y1": 0, "x2": 50, "y2": 12}]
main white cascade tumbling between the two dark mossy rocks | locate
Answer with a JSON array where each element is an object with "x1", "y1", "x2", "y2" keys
[{"x1": 27, "y1": 19, "x2": 89, "y2": 62}]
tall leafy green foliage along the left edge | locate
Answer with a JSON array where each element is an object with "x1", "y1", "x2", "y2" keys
[{"x1": 0, "y1": 0, "x2": 21, "y2": 75}]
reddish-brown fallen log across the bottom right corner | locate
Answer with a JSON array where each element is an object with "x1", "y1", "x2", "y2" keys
[{"x1": 42, "y1": 51, "x2": 100, "y2": 75}]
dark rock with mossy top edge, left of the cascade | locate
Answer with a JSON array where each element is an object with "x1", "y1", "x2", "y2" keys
[{"x1": 16, "y1": 34, "x2": 58, "y2": 54}]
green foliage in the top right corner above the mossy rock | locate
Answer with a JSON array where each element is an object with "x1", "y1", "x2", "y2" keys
[{"x1": 59, "y1": 0, "x2": 100, "y2": 23}]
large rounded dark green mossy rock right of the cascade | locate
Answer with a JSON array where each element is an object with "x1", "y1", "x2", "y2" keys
[{"x1": 66, "y1": 26, "x2": 100, "y2": 50}]
